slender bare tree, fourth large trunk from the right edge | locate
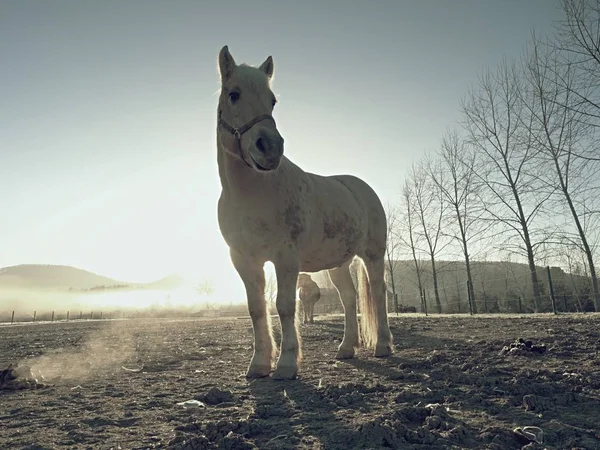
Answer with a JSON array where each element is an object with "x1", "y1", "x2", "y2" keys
[{"x1": 408, "y1": 162, "x2": 446, "y2": 314}]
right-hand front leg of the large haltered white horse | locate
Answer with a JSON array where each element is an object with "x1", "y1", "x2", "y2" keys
[{"x1": 273, "y1": 260, "x2": 301, "y2": 380}]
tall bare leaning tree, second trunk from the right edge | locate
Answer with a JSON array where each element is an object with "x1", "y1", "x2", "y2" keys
[{"x1": 462, "y1": 60, "x2": 547, "y2": 312}]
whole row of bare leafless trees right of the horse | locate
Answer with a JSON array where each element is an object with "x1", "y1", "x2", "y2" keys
[{"x1": 387, "y1": 0, "x2": 600, "y2": 312}]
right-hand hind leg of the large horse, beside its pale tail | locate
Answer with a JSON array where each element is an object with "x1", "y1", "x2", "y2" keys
[{"x1": 361, "y1": 256, "x2": 393, "y2": 357}]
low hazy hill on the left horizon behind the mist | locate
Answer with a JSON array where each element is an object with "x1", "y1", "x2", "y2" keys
[{"x1": 0, "y1": 264, "x2": 181, "y2": 292}]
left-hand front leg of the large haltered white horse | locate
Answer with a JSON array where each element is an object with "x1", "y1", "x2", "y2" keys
[{"x1": 231, "y1": 250, "x2": 277, "y2": 378}]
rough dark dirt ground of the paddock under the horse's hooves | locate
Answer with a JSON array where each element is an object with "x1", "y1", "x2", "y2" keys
[{"x1": 0, "y1": 314, "x2": 600, "y2": 449}]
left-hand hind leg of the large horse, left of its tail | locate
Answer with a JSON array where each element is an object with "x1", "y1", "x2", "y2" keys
[{"x1": 328, "y1": 260, "x2": 358, "y2": 359}]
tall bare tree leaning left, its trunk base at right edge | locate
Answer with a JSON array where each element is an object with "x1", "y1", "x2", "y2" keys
[{"x1": 523, "y1": 36, "x2": 600, "y2": 311}]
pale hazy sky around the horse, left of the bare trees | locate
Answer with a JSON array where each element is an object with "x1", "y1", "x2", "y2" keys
[{"x1": 0, "y1": 0, "x2": 561, "y2": 300}]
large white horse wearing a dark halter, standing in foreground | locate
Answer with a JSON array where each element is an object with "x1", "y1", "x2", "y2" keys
[{"x1": 217, "y1": 46, "x2": 393, "y2": 379}]
